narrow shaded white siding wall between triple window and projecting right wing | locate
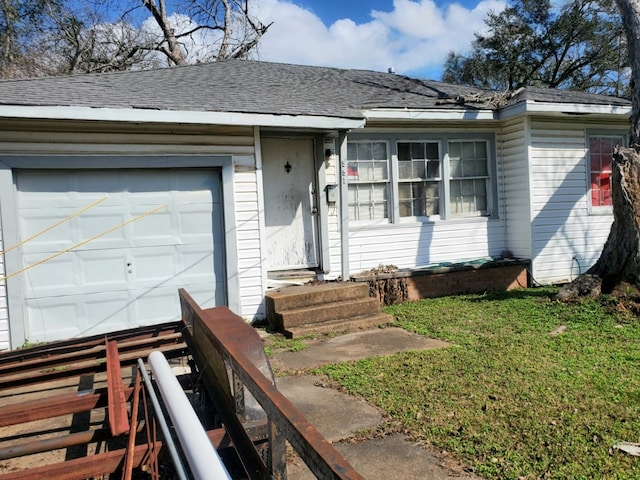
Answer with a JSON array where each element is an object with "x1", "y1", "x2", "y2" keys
[{"x1": 502, "y1": 118, "x2": 533, "y2": 258}]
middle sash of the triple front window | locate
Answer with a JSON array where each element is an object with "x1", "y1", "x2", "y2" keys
[{"x1": 398, "y1": 142, "x2": 441, "y2": 217}]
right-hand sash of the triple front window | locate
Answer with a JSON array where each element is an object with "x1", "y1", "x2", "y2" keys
[{"x1": 449, "y1": 141, "x2": 489, "y2": 216}]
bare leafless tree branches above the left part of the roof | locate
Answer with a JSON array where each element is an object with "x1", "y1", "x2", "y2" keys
[{"x1": 0, "y1": 0, "x2": 269, "y2": 78}]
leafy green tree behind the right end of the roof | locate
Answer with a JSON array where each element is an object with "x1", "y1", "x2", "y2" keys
[{"x1": 443, "y1": 0, "x2": 627, "y2": 94}]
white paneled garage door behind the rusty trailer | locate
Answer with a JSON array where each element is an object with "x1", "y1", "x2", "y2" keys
[{"x1": 17, "y1": 169, "x2": 226, "y2": 341}]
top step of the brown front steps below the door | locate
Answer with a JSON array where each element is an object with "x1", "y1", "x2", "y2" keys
[{"x1": 265, "y1": 282, "x2": 369, "y2": 315}]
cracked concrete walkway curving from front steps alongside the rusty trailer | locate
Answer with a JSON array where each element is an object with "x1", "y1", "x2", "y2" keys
[{"x1": 270, "y1": 327, "x2": 479, "y2": 480}]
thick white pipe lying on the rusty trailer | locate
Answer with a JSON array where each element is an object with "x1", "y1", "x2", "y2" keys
[{"x1": 149, "y1": 351, "x2": 231, "y2": 480}]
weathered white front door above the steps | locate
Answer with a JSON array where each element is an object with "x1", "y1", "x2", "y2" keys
[{"x1": 262, "y1": 138, "x2": 318, "y2": 271}]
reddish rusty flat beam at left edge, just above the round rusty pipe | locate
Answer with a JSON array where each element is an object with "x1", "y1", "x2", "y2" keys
[{"x1": 0, "y1": 387, "x2": 133, "y2": 427}]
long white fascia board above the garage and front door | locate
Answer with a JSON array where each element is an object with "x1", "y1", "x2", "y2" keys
[{"x1": 0, "y1": 105, "x2": 365, "y2": 129}]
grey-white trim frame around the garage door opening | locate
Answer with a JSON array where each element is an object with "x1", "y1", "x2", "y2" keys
[{"x1": 0, "y1": 155, "x2": 241, "y2": 348}]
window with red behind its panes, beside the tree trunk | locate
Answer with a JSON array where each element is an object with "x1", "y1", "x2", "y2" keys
[{"x1": 589, "y1": 135, "x2": 624, "y2": 207}]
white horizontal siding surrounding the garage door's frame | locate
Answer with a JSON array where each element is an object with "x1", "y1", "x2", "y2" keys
[{"x1": 0, "y1": 123, "x2": 265, "y2": 349}]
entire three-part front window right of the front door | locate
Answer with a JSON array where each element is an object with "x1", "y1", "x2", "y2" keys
[{"x1": 344, "y1": 133, "x2": 497, "y2": 223}]
